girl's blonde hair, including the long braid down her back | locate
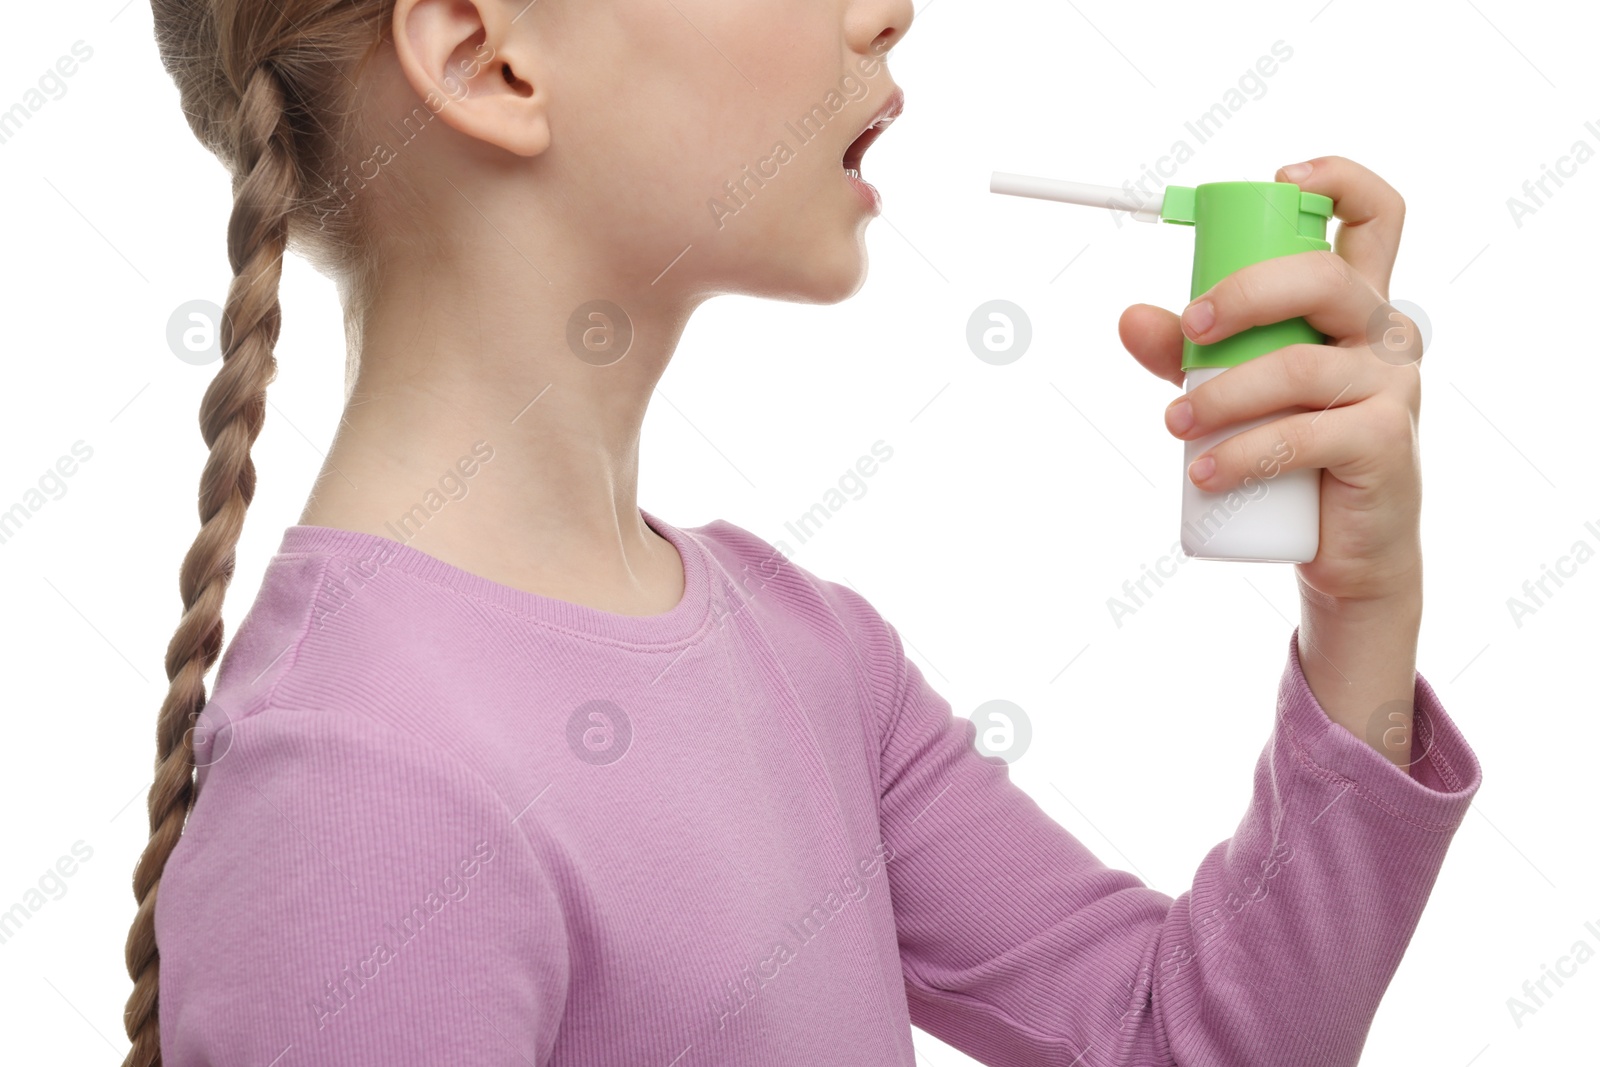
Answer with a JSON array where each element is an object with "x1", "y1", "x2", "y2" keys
[{"x1": 123, "y1": 0, "x2": 406, "y2": 1067}]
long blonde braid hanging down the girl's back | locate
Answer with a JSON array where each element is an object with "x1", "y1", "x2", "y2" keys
[{"x1": 123, "y1": 61, "x2": 299, "y2": 1067}]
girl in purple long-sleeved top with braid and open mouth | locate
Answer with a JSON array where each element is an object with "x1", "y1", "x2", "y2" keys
[{"x1": 126, "y1": 0, "x2": 1480, "y2": 1067}]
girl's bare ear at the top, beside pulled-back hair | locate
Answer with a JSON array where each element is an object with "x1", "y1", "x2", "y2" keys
[{"x1": 394, "y1": 0, "x2": 550, "y2": 157}]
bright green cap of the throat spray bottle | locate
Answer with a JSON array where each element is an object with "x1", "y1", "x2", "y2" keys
[{"x1": 1162, "y1": 181, "x2": 1333, "y2": 371}]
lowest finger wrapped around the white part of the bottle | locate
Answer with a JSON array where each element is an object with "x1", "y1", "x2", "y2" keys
[{"x1": 1189, "y1": 395, "x2": 1416, "y2": 493}]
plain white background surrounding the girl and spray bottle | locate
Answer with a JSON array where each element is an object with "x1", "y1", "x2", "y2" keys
[{"x1": 0, "y1": 0, "x2": 1600, "y2": 1067}]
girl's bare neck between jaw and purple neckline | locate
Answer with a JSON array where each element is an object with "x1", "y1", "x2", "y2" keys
[{"x1": 299, "y1": 254, "x2": 690, "y2": 614}]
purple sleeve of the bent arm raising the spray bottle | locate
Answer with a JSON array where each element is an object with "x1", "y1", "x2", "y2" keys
[{"x1": 842, "y1": 590, "x2": 1480, "y2": 1067}]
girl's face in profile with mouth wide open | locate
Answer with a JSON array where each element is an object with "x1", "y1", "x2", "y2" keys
[{"x1": 518, "y1": 0, "x2": 914, "y2": 302}]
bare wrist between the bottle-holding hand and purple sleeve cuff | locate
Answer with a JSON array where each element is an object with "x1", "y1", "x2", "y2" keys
[{"x1": 1299, "y1": 576, "x2": 1422, "y2": 768}]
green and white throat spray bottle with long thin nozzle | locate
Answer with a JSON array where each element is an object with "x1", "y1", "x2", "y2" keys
[{"x1": 989, "y1": 171, "x2": 1333, "y2": 563}]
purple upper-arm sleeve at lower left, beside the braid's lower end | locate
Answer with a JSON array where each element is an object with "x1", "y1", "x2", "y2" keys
[{"x1": 155, "y1": 709, "x2": 568, "y2": 1067}]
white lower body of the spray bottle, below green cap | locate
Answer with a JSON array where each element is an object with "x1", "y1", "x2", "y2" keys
[{"x1": 1181, "y1": 366, "x2": 1322, "y2": 563}]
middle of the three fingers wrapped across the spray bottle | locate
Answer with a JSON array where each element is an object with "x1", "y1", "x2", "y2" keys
[{"x1": 1166, "y1": 344, "x2": 1388, "y2": 440}]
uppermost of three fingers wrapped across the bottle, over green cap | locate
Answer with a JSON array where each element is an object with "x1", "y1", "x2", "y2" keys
[{"x1": 1182, "y1": 251, "x2": 1386, "y2": 344}]
